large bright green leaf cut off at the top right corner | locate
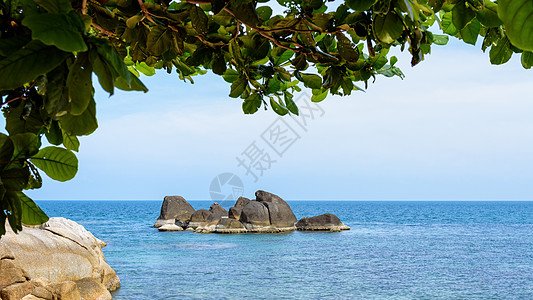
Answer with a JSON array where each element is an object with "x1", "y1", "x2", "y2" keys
[{"x1": 498, "y1": 0, "x2": 533, "y2": 51}]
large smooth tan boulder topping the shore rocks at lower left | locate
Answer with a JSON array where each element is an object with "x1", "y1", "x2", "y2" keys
[{"x1": 0, "y1": 218, "x2": 120, "y2": 292}]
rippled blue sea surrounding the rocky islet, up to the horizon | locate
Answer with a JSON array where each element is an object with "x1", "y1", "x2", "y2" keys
[{"x1": 38, "y1": 201, "x2": 533, "y2": 299}]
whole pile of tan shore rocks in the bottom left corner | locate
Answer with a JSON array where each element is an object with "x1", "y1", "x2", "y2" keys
[{"x1": 0, "y1": 218, "x2": 120, "y2": 300}]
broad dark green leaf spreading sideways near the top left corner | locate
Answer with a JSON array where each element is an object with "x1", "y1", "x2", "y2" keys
[{"x1": 22, "y1": 11, "x2": 87, "y2": 52}]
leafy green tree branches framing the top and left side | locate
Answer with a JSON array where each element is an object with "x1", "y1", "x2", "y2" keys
[{"x1": 0, "y1": 0, "x2": 533, "y2": 236}]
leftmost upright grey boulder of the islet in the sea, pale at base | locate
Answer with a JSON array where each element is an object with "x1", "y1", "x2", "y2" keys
[{"x1": 154, "y1": 196, "x2": 194, "y2": 228}]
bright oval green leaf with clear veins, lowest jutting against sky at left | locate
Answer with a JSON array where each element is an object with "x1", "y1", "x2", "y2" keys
[{"x1": 31, "y1": 147, "x2": 78, "y2": 181}]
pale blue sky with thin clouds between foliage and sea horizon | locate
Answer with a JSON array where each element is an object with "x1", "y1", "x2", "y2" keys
[{"x1": 16, "y1": 40, "x2": 533, "y2": 200}]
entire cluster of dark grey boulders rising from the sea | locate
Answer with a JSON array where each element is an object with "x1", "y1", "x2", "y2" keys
[{"x1": 154, "y1": 190, "x2": 350, "y2": 233}]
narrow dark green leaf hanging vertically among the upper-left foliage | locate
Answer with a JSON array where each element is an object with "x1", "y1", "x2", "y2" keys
[{"x1": 67, "y1": 54, "x2": 94, "y2": 116}]
